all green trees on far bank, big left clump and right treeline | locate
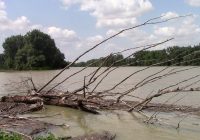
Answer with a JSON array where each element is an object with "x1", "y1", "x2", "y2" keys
[{"x1": 0, "y1": 30, "x2": 200, "y2": 70}]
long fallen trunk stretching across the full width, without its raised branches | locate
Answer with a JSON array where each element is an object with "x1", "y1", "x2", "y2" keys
[{"x1": 0, "y1": 89, "x2": 200, "y2": 115}]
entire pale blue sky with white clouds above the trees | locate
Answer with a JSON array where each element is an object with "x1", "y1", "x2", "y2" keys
[{"x1": 0, "y1": 0, "x2": 200, "y2": 61}]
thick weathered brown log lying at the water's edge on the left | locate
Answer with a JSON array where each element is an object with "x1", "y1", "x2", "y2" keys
[{"x1": 1, "y1": 94, "x2": 100, "y2": 114}]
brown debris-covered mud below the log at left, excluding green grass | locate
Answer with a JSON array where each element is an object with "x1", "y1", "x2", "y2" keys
[{"x1": 0, "y1": 102, "x2": 54, "y2": 140}]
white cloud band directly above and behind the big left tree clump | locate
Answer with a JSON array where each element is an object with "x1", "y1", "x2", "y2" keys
[{"x1": 0, "y1": 0, "x2": 79, "y2": 59}]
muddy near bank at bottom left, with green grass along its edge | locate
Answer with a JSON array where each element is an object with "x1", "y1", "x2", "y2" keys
[{"x1": 0, "y1": 102, "x2": 115, "y2": 140}]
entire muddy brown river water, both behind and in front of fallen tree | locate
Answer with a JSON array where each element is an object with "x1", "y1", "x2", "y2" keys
[{"x1": 0, "y1": 67, "x2": 200, "y2": 140}]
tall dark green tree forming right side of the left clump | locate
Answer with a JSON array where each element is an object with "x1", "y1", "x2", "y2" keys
[{"x1": 25, "y1": 30, "x2": 66, "y2": 68}]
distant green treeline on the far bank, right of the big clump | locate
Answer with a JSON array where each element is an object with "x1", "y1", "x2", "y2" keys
[{"x1": 75, "y1": 44, "x2": 200, "y2": 67}]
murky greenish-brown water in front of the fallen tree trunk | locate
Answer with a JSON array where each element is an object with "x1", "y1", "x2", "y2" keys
[{"x1": 27, "y1": 106, "x2": 200, "y2": 140}]
